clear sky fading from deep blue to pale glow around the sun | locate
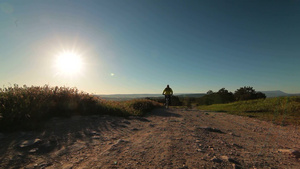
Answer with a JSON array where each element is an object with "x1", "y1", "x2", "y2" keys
[{"x1": 0, "y1": 0, "x2": 300, "y2": 94}]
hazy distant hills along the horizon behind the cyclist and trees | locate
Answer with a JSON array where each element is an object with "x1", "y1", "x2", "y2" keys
[{"x1": 95, "y1": 90, "x2": 300, "y2": 101}]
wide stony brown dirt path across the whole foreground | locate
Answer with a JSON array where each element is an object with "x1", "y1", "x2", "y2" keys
[{"x1": 0, "y1": 108, "x2": 300, "y2": 168}]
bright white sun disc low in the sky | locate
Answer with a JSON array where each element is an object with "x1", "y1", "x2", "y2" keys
[{"x1": 55, "y1": 51, "x2": 83, "y2": 75}]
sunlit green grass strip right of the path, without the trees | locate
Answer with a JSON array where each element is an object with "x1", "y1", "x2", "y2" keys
[{"x1": 198, "y1": 97, "x2": 300, "y2": 125}]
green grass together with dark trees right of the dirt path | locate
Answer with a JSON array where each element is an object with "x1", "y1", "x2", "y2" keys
[{"x1": 173, "y1": 86, "x2": 300, "y2": 125}]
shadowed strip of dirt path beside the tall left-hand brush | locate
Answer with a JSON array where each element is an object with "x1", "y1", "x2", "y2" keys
[{"x1": 0, "y1": 108, "x2": 181, "y2": 168}]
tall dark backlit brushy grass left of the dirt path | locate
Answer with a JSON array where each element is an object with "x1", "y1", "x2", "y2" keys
[{"x1": 0, "y1": 85, "x2": 159, "y2": 131}]
